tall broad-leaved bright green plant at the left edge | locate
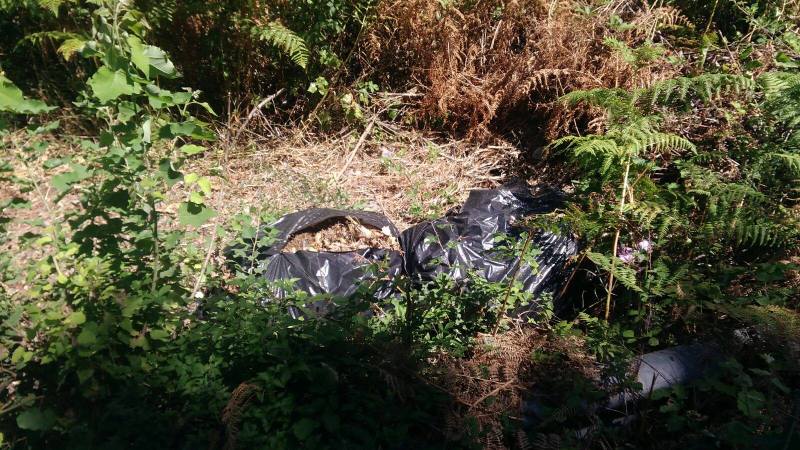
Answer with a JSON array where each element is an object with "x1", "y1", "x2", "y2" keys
[{"x1": 2, "y1": 1, "x2": 219, "y2": 442}]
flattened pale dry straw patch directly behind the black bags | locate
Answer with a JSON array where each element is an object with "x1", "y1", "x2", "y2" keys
[{"x1": 193, "y1": 119, "x2": 519, "y2": 230}]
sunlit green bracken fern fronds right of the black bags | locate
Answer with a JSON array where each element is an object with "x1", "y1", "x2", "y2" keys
[{"x1": 553, "y1": 65, "x2": 799, "y2": 326}]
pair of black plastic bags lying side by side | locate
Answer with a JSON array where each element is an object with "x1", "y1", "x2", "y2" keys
[{"x1": 228, "y1": 184, "x2": 578, "y2": 314}]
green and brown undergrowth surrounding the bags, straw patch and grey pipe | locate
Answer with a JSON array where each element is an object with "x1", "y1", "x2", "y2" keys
[{"x1": 0, "y1": 0, "x2": 800, "y2": 449}]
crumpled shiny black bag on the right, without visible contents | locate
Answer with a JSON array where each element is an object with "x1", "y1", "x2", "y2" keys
[{"x1": 400, "y1": 184, "x2": 578, "y2": 310}]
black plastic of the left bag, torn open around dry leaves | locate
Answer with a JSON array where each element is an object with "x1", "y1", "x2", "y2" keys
[{"x1": 228, "y1": 208, "x2": 402, "y2": 306}]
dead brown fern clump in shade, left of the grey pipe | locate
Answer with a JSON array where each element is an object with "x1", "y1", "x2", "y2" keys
[{"x1": 438, "y1": 327, "x2": 600, "y2": 450}]
